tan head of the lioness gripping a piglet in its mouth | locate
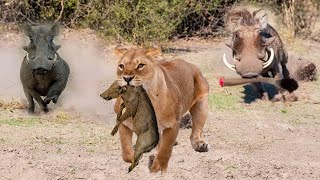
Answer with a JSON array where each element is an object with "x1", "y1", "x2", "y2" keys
[{"x1": 115, "y1": 46, "x2": 160, "y2": 86}]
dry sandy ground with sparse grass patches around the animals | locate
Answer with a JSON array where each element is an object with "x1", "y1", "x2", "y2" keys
[{"x1": 0, "y1": 30, "x2": 320, "y2": 179}]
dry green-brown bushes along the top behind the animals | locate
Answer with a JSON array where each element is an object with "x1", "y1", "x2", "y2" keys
[{"x1": 0, "y1": 0, "x2": 320, "y2": 44}]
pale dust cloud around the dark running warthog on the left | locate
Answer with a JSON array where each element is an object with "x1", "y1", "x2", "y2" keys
[{"x1": 0, "y1": 29, "x2": 116, "y2": 115}]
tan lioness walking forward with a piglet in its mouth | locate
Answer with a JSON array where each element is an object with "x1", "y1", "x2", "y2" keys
[{"x1": 115, "y1": 46, "x2": 209, "y2": 172}]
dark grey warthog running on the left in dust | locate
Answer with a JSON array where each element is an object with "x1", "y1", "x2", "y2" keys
[{"x1": 20, "y1": 24, "x2": 70, "y2": 113}]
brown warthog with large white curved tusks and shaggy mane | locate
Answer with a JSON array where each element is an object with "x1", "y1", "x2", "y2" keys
[{"x1": 223, "y1": 10, "x2": 296, "y2": 98}]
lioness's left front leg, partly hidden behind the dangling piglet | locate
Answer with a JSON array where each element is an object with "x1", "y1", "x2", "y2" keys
[{"x1": 119, "y1": 124, "x2": 134, "y2": 163}]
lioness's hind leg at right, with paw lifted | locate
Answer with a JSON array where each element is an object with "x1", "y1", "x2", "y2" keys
[{"x1": 190, "y1": 96, "x2": 209, "y2": 152}]
